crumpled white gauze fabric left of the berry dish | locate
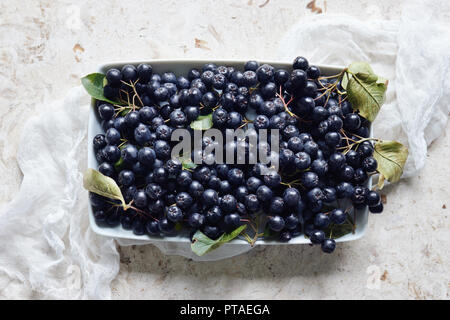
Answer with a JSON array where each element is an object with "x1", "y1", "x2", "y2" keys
[{"x1": 0, "y1": 87, "x2": 119, "y2": 299}]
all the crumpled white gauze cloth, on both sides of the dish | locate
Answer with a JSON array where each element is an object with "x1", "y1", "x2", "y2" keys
[{"x1": 0, "y1": 1, "x2": 450, "y2": 299}]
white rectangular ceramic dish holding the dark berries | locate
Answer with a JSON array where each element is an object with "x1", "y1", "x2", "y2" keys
[{"x1": 88, "y1": 59, "x2": 372, "y2": 246}]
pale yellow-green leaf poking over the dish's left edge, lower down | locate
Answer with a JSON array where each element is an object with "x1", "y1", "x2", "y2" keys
[{"x1": 83, "y1": 169, "x2": 126, "y2": 207}]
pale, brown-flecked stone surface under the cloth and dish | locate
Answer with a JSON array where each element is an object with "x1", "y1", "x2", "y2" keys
[{"x1": 0, "y1": 0, "x2": 450, "y2": 299}]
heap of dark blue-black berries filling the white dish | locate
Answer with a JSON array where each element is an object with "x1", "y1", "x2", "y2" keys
[{"x1": 90, "y1": 57, "x2": 383, "y2": 253}]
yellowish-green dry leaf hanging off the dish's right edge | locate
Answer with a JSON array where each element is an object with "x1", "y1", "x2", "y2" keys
[{"x1": 373, "y1": 141, "x2": 408, "y2": 189}]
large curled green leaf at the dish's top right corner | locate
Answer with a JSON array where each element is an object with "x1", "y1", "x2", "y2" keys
[{"x1": 343, "y1": 62, "x2": 388, "y2": 122}]
